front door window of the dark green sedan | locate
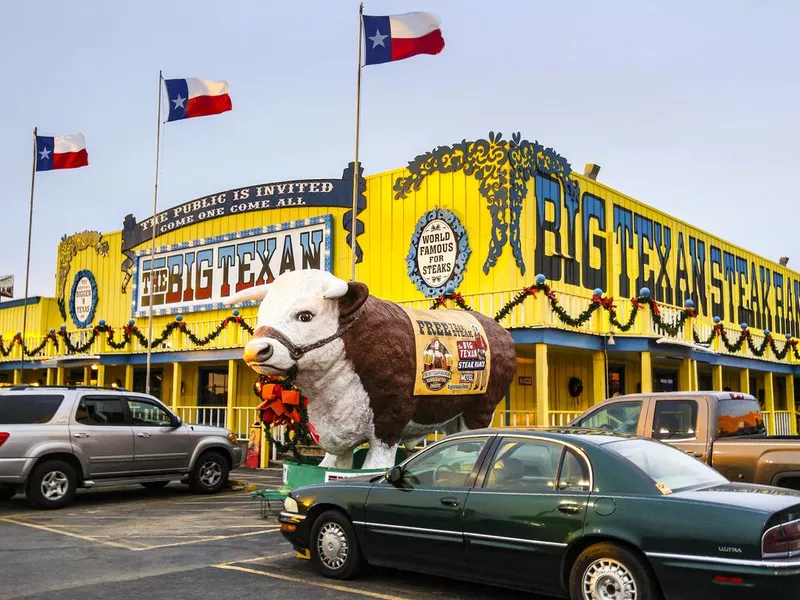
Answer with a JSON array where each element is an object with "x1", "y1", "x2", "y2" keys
[{"x1": 403, "y1": 438, "x2": 486, "y2": 488}]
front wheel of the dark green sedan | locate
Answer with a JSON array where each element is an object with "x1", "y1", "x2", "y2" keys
[{"x1": 309, "y1": 510, "x2": 365, "y2": 579}]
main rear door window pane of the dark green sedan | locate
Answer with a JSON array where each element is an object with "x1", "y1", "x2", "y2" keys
[{"x1": 484, "y1": 439, "x2": 564, "y2": 492}]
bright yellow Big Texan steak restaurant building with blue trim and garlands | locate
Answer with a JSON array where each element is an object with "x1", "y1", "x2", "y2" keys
[{"x1": 0, "y1": 134, "x2": 800, "y2": 438}]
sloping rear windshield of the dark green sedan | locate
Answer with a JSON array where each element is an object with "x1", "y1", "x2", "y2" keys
[{"x1": 604, "y1": 440, "x2": 728, "y2": 493}]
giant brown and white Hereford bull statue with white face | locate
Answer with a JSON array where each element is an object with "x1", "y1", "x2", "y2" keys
[{"x1": 226, "y1": 269, "x2": 516, "y2": 469}]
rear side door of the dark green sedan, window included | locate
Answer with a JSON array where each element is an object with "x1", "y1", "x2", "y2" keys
[{"x1": 464, "y1": 436, "x2": 591, "y2": 593}]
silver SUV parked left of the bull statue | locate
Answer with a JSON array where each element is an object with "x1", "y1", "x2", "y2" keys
[{"x1": 0, "y1": 386, "x2": 242, "y2": 508}]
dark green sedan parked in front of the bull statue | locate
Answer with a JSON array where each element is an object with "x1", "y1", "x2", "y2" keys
[{"x1": 280, "y1": 429, "x2": 800, "y2": 600}]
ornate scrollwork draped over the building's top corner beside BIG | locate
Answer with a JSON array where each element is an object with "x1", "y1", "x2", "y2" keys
[{"x1": 394, "y1": 132, "x2": 580, "y2": 274}]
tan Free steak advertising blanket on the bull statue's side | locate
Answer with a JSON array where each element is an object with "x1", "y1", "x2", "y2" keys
[{"x1": 403, "y1": 307, "x2": 491, "y2": 396}]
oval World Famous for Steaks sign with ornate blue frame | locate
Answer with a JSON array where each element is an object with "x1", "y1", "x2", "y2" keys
[{"x1": 406, "y1": 208, "x2": 471, "y2": 297}]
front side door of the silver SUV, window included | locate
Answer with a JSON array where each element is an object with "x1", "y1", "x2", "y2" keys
[{"x1": 125, "y1": 397, "x2": 190, "y2": 473}]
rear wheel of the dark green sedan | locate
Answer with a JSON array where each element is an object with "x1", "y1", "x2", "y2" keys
[{"x1": 569, "y1": 542, "x2": 662, "y2": 600}]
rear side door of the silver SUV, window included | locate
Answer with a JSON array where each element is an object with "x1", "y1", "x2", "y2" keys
[{"x1": 69, "y1": 394, "x2": 133, "y2": 477}]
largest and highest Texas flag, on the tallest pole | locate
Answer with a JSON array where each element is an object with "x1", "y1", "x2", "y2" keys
[{"x1": 363, "y1": 12, "x2": 444, "y2": 65}]
